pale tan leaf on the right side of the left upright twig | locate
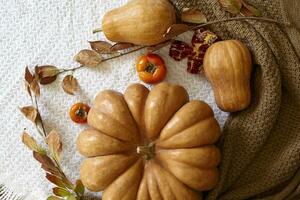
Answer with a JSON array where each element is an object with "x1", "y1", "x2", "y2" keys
[{"x1": 46, "y1": 130, "x2": 62, "y2": 162}]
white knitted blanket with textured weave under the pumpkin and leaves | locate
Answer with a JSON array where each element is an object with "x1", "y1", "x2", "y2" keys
[{"x1": 0, "y1": 0, "x2": 227, "y2": 200}]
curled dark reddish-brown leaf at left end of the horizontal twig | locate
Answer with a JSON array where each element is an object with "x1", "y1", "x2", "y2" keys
[{"x1": 35, "y1": 65, "x2": 59, "y2": 85}]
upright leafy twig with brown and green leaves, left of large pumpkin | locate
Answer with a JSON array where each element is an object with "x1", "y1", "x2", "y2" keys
[{"x1": 20, "y1": 68, "x2": 84, "y2": 200}]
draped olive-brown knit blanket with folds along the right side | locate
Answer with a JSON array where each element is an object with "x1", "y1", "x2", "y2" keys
[{"x1": 173, "y1": 0, "x2": 300, "y2": 200}]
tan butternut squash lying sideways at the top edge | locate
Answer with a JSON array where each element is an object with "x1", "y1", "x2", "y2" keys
[{"x1": 102, "y1": 0, "x2": 176, "y2": 45}]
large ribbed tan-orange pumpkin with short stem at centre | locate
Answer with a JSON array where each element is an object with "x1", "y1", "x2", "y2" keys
[{"x1": 77, "y1": 83, "x2": 220, "y2": 200}]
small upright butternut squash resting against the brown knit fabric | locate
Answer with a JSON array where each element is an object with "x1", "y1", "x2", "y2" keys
[{"x1": 203, "y1": 40, "x2": 252, "y2": 112}]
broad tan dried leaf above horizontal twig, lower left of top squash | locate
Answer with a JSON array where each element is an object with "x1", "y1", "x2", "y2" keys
[{"x1": 74, "y1": 49, "x2": 102, "y2": 67}]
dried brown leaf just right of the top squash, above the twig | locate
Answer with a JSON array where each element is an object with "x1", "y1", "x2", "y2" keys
[{"x1": 181, "y1": 8, "x2": 207, "y2": 24}]
